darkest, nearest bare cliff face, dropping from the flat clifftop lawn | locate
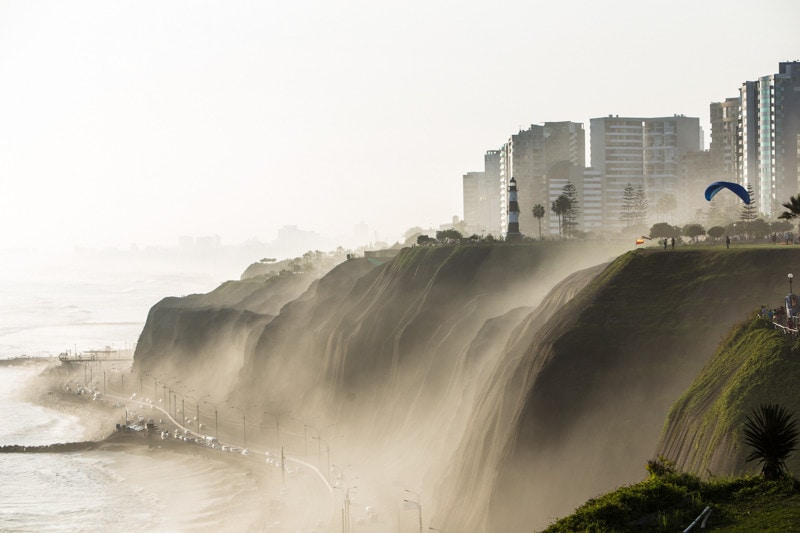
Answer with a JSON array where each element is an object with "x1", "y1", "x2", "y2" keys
[{"x1": 441, "y1": 248, "x2": 800, "y2": 531}]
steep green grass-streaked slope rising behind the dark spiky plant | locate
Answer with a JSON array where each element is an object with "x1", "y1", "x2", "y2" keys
[{"x1": 657, "y1": 318, "x2": 800, "y2": 477}]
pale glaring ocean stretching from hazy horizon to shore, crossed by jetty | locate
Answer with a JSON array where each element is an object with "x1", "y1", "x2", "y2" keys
[{"x1": 0, "y1": 250, "x2": 270, "y2": 532}]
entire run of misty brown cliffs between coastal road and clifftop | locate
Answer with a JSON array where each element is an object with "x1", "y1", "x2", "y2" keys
[{"x1": 135, "y1": 243, "x2": 800, "y2": 532}]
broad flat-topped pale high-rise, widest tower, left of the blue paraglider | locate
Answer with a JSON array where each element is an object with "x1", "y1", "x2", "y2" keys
[{"x1": 590, "y1": 115, "x2": 702, "y2": 230}]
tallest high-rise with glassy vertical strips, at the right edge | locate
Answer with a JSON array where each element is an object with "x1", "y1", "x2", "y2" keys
[{"x1": 737, "y1": 61, "x2": 800, "y2": 216}]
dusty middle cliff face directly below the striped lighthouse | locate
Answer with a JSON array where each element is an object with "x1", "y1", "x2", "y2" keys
[{"x1": 231, "y1": 245, "x2": 620, "y2": 448}]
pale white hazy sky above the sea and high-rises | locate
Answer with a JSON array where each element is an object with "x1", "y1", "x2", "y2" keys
[{"x1": 0, "y1": 0, "x2": 800, "y2": 249}]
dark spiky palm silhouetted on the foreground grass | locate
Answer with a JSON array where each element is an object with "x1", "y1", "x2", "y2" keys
[{"x1": 744, "y1": 404, "x2": 800, "y2": 480}]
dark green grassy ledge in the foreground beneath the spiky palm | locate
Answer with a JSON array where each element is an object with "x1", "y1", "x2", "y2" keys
[{"x1": 544, "y1": 462, "x2": 800, "y2": 533}]
